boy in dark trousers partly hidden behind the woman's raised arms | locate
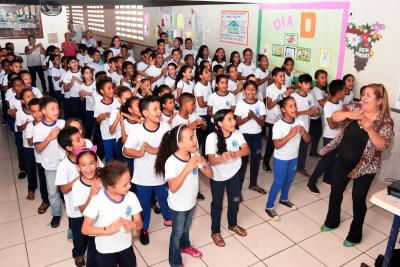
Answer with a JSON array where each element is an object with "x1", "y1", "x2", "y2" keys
[{"x1": 307, "y1": 80, "x2": 347, "y2": 195}]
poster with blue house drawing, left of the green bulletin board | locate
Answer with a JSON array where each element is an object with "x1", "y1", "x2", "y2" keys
[{"x1": 220, "y1": 10, "x2": 249, "y2": 45}]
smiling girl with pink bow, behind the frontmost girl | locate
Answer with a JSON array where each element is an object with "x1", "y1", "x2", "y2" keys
[{"x1": 71, "y1": 147, "x2": 102, "y2": 266}]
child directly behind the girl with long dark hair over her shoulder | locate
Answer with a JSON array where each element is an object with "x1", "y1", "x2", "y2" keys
[{"x1": 207, "y1": 74, "x2": 236, "y2": 120}]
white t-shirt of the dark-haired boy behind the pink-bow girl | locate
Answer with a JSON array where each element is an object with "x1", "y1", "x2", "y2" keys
[{"x1": 54, "y1": 157, "x2": 82, "y2": 218}]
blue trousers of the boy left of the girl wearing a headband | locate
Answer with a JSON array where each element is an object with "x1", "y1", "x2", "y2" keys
[{"x1": 136, "y1": 184, "x2": 171, "y2": 230}]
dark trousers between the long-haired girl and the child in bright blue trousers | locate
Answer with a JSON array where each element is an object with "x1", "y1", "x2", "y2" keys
[{"x1": 240, "y1": 133, "x2": 261, "y2": 190}]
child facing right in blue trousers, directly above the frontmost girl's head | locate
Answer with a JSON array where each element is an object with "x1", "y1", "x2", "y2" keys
[{"x1": 93, "y1": 78, "x2": 120, "y2": 162}]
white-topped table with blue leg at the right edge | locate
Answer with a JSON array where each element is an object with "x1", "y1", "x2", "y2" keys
[{"x1": 370, "y1": 189, "x2": 400, "y2": 267}]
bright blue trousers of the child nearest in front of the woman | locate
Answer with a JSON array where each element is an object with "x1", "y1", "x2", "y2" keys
[{"x1": 267, "y1": 158, "x2": 297, "y2": 209}]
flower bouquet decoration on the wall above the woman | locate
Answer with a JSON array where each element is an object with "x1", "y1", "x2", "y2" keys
[{"x1": 346, "y1": 22, "x2": 385, "y2": 72}]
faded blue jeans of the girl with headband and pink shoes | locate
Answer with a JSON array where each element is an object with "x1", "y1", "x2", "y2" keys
[{"x1": 168, "y1": 206, "x2": 196, "y2": 267}]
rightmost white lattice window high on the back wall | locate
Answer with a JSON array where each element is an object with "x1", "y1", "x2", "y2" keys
[{"x1": 115, "y1": 5, "x2": 144, "y2": 40}]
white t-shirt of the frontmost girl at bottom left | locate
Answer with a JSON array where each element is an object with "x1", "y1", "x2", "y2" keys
[{"x1": 83, "y1": 190, "x2": 142, "y2": 254}]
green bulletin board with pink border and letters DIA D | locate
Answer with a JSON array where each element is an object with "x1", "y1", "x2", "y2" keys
[{"x1": 257, "y1": 2, "x2": 350, "y2": 79}]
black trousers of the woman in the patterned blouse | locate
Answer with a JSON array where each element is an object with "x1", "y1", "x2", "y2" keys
[{"x1": 325, "y1": 160, "x2": 375, "y2": 243}]
